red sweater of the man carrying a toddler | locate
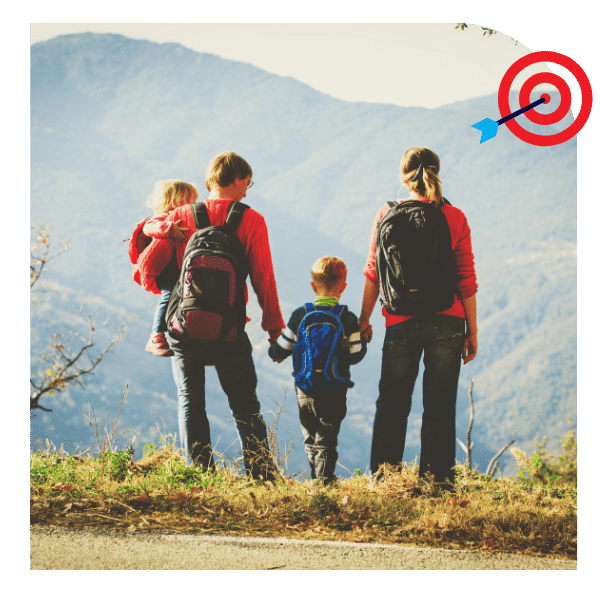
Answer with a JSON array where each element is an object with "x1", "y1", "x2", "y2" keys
[{"x1": 161, "y1": 200, "x2": 285, "y2": 339}]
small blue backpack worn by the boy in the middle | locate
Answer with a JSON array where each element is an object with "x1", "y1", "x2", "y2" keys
[{"x1": 292, "y1": 303, "x2": 348, "y2": 391}]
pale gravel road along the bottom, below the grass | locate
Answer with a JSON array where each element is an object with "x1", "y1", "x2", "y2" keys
[{"x1": 31, "y1": 525, "x2": 577, "y2": 571}]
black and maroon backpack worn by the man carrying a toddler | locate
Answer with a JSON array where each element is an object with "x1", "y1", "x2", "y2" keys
[{"x1": 166, "y1": 202, "x2": 248, "y2": 341}]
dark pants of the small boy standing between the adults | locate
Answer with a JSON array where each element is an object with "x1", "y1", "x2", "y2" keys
[{"x1": 296, "y1": 387, "x2": 348, "y2": 484}]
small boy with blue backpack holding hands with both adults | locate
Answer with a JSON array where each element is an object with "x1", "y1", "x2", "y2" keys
[{"x1": 269, "y1": 256, "x2": 367, "y2": 485}]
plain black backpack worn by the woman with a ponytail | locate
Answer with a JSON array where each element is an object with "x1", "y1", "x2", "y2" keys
[{"x1": 376, "y1": 198, "x2": 457, "y2": 316}]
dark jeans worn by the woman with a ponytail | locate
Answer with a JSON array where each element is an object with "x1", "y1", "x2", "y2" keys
[{"x1": 371, "y1": 315, "x2": 465, "y2": 483}]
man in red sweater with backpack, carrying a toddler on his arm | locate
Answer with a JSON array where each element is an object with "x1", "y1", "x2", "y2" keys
[{"x1": 166, "y1": 152, "x2": 285, "y2": 480}]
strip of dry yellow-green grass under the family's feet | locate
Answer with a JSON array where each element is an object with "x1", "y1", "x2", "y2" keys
[{"x1": 30, "y1": 440, "x2": 577, "y2": 559}]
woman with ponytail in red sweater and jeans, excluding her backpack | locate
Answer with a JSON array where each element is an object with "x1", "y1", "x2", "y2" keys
[{"x1": 359, "y1": 147, "x2": 477, "y2": 489}]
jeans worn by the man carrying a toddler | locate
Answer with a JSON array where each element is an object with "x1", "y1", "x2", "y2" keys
[{"x1": 169, "y1": 332, "x2": 275, "y2": 479}]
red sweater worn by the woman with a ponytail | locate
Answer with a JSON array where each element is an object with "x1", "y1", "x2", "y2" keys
[{"x1": 363, "y1": 198, "x2": 477, "y2": 327}]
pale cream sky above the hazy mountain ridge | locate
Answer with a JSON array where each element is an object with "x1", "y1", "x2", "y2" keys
[{"x1": 31, "y1": 22, "x2": 554, "y2": 112}]
